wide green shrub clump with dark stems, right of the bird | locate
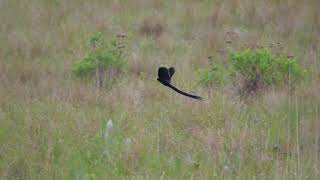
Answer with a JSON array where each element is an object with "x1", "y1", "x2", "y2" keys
[{"x1": 199, "y1": 48, "x2": 306, "y2": 94}]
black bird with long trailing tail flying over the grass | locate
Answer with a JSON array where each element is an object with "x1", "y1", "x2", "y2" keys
[{"x1": 157, "y1": 67, "x2": 202, "y2": 100}]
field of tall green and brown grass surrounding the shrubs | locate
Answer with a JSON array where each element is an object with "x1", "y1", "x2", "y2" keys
[{"x1": 0, "y1": 0, "x2": 320, "y2": 179}]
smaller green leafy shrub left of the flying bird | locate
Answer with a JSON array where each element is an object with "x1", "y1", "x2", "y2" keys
[{"x1": 72, "y1": 32, "x2": 127, "y2": 87}]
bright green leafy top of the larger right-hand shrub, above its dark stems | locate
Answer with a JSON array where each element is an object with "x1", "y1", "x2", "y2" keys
[{"x1": 229, "y1": 48, "x2": 306, "y2": 85}]
